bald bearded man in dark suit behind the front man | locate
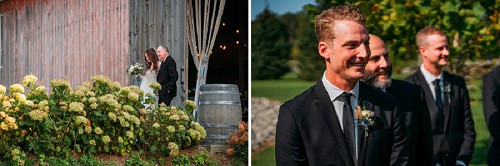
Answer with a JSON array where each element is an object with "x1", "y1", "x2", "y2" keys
[{"x1": 363, "y1": 34, "x2": 433, "y2": 165}]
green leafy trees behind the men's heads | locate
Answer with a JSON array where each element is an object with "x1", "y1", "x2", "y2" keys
[{"x1": 251, "y1": 0, "x2": 500, "y2": 80}]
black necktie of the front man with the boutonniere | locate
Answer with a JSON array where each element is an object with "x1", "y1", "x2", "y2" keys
[{"x1": 339, "y1": 92, "x2": 357, "y2": 165}]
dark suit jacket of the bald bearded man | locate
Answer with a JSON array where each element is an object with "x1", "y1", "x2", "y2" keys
[{"x1": 386, "y1": 79, "x2": 433, "y2": 165}]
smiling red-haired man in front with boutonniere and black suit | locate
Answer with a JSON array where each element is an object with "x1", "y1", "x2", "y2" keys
[{"x1": 276, "y1": 6, "x2": 407, "y2": 166}]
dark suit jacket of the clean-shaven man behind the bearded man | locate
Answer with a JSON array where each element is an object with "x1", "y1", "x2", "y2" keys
[{"x1": 406, "y1": 70, "x2": 476, "y2": 165}]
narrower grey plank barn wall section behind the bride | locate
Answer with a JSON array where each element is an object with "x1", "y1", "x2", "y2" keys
[{"x1": 129, "y1": 0, "x2": 189, "y2": 105}]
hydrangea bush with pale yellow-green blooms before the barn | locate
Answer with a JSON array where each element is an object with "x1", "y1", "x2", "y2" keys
[{"x1": 0, "y1": 75, "x2": 206, "y2": 163}]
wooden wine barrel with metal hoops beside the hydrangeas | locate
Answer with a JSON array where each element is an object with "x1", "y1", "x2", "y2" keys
[{"x1": 198, "y1": 84, "x2": 242, "y2": 145}]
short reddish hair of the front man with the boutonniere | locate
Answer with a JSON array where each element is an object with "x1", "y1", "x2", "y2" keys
[{"x1": 315, "y1": 5, "x2": 366, "y2": 41}]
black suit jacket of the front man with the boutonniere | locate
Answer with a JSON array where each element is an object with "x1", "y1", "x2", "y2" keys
[{"x1": 276, "y1": 81, "x2": 408, "y2": 166}]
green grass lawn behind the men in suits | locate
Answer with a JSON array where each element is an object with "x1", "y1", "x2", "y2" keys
[{"x1": 252, "y1": 75, "x2": 490, "y2": 166}]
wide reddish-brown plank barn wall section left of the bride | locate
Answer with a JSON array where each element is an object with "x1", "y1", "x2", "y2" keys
[{"x1": 0, "y1": 0, "x2": 130, "y2": 87}]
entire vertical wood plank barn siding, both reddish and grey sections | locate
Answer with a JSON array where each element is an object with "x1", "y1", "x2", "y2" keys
[{"x1": 0, "y1": 0, "x2": 187, "y2": 105}]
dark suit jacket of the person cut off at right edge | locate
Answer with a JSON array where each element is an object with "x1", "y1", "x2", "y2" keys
[{"x1": 483, "y1": 67, "x2": 500, "y2": 165}]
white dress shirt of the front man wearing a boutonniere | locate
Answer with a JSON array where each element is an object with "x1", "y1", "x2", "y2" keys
[{"x1": 321, "y1": 73, "x2": 359, "y2": 158}]
